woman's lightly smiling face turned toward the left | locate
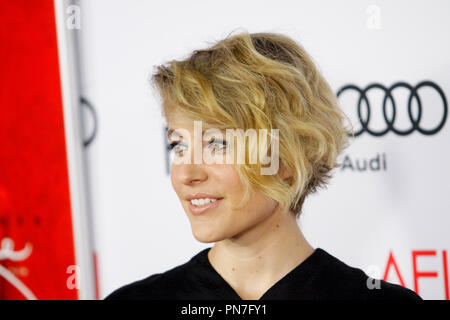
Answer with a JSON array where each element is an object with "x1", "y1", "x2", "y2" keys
[{"x1": 168, "y1": 116, "x2": 277, "y2": 243}]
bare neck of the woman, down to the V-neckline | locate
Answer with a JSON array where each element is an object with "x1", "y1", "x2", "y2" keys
[{"x1": 208, "y1": 207, "x2": 314, "y2": 299}]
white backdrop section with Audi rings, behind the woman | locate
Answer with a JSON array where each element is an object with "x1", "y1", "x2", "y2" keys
[{"x1": 79, "y1": 0, "x2": 450, "y2": 299}]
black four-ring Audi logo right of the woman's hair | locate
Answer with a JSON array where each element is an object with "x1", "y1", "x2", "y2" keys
[{"x1": 337, "y1": 81, "x2": 447, "y2": 137}]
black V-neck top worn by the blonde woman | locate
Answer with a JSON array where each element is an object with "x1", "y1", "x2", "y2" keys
[{"x1": 105, "y1": 248, "x2": 421, "y2": 300}]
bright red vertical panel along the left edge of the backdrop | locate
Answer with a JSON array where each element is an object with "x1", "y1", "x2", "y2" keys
[{"x1": 0, "y1": 0, "x2": 78, "y2": 299}]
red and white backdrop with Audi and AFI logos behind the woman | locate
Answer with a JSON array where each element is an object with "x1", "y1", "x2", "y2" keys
[{"x1": 0, "y1": 0, "x2": 450, "y2": 300}]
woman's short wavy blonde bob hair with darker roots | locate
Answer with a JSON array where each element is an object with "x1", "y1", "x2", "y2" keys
[{"x1": 151, "y1": 31, "x2": 352, "y2": 218}]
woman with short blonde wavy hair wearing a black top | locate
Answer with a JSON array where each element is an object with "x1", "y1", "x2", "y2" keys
[{"x1": 107, "y1": 32, "x2": 420, "y2": 299}]
